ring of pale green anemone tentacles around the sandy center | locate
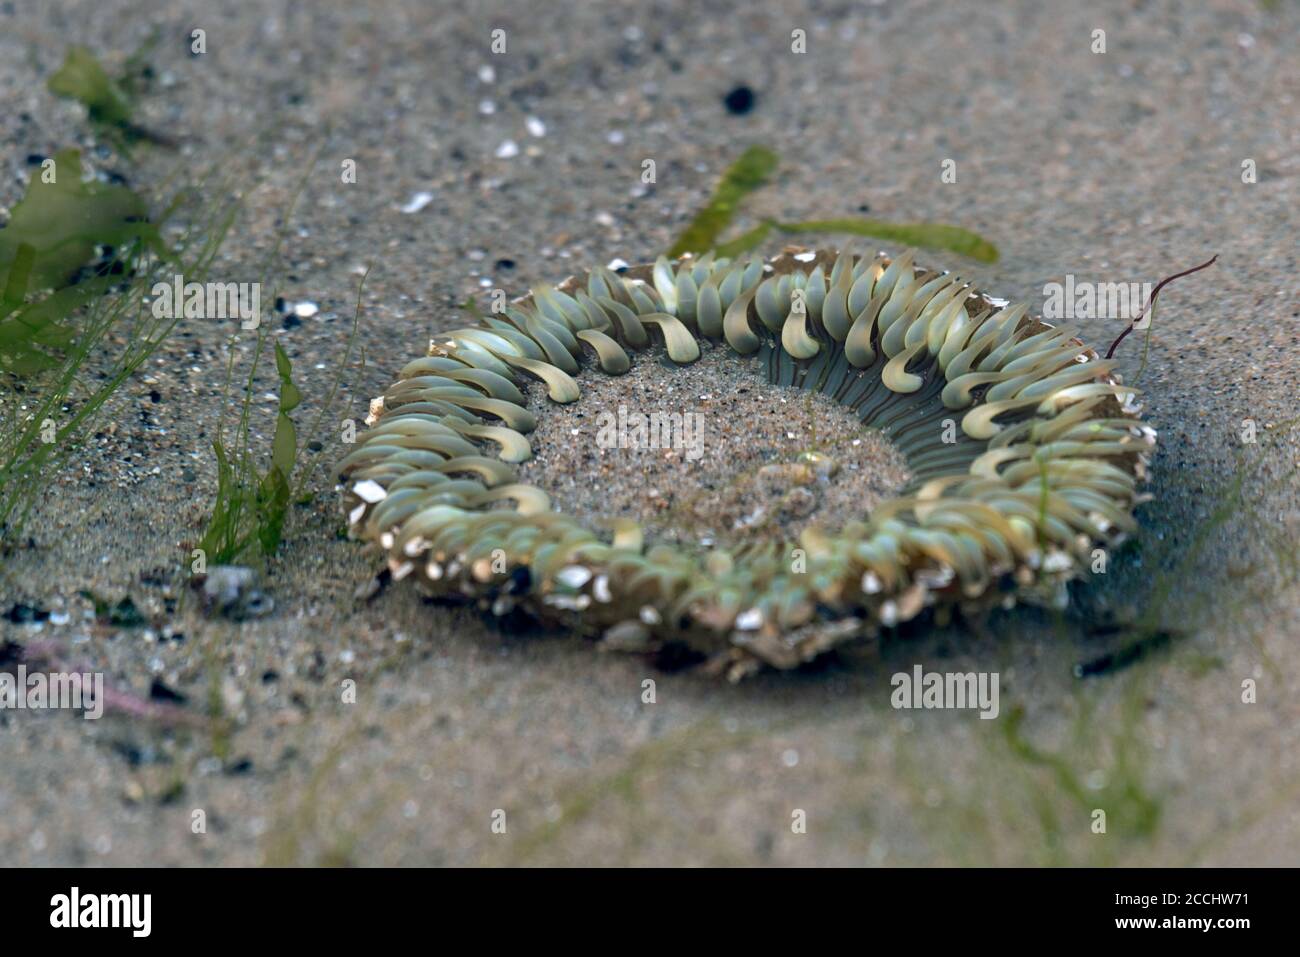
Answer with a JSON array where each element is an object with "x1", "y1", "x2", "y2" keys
[{"x1": 339, "y1": 248, "x2": 1156, "y2": 679}]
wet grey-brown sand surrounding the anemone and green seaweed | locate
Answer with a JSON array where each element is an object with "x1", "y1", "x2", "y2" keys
[{"x1": 0, "y1": 0, "x2": 1300, "y2": 866}]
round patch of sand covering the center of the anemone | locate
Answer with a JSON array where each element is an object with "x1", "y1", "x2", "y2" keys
[{"x1": 519, "y1": 343, "x2": 911, "y2": 547}]
